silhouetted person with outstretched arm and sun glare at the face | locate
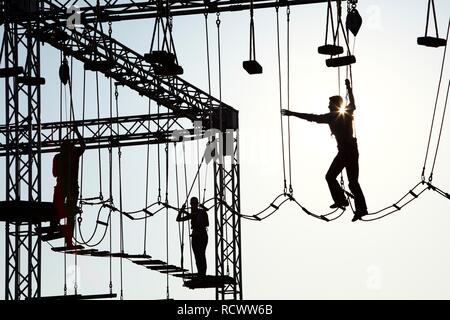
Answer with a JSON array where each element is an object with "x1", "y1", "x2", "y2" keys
[{"x1": 281, "y1": 79, "x2": 367, "y2": 221}]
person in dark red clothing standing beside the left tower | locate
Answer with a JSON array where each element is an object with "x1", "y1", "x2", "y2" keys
[{"x1": 52, "y1": 126, "x2": 86, "y2": 247}]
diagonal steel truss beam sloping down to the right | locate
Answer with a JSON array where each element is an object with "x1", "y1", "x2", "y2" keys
[{"x1": 33, "y1": 13, "x2": 234, "y2": 121}]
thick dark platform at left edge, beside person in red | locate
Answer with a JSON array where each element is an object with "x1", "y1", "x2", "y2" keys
[{"x1": 0, "y1": 201, "x2": 56, "y2": 224}]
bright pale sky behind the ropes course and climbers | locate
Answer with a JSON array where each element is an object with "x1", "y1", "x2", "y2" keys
[{"x1": 0, "y1": 0, "x2": 450, "y2": 299}]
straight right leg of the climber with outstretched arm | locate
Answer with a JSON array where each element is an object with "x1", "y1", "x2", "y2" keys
[{"x1": 345, "y1": 145, "x2": 367, "y2": 215}]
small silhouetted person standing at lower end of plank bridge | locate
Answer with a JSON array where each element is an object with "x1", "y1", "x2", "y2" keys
[{"x1": 177, "y1": 197, "x2": 209, "y2": 277}]
